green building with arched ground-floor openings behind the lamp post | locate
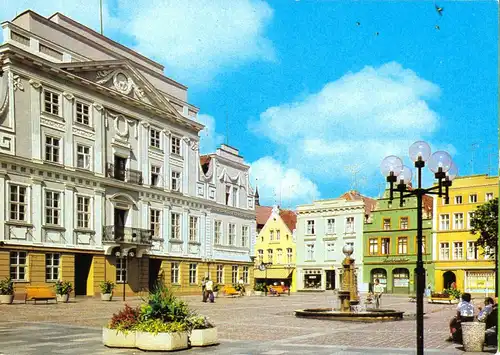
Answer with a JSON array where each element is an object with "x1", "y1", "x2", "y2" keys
[{"x1": 363, "y1": 190, "x2": 434, "y2": 294}]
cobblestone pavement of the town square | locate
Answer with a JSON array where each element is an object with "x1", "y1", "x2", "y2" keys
[{"x1": 0, "y1": 293, "x2": 494, "y2": 355}]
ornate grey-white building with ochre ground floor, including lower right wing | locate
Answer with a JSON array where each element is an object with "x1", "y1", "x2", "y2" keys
[{"x1": 0, "y1": 11, "x2": 255, "y2": 295}]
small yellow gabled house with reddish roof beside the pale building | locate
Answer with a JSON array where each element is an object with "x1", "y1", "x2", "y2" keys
[{"x1": 254, "y1": 205, "x2": 297, "y2": 291}]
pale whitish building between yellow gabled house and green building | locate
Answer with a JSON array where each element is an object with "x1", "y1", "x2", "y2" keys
[{"x1": 296, "y1": 191, "x2": 372, "y2": 291}]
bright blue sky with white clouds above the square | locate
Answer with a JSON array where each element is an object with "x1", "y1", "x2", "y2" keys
[{"x1": 0, "y1": 0, "x2": 498, "y2": 208}]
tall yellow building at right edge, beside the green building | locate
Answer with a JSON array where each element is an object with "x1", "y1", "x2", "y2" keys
[{"x1": 433, "y1": 174, "x2": 498, "y2": 294}]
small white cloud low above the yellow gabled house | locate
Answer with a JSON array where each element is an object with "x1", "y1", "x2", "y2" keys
[{"x1": 250, "y1": 157, "x2": 319, "y2": 207}]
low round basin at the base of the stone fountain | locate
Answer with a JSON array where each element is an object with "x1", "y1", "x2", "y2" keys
[{"x1": 295, "y1": 308, "x2": 404, "y2": 322}]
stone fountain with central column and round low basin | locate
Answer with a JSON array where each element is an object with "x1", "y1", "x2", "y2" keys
[{"x1": 295, "y1": 245, "x2": 404, "y2": 322}]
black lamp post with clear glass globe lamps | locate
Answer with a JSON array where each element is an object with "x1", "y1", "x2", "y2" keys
[{"x1": 380, "y1": 141, "x2": 458, "y2": 355}]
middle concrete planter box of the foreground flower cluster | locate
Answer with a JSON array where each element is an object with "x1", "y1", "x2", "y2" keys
[{"x1": 135, "y1": 332, "x2": 188, "y2": 351}]
